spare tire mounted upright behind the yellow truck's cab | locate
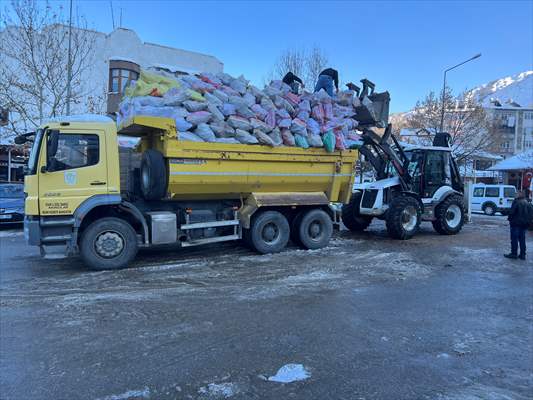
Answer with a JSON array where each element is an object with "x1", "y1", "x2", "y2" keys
[{"x1": 141, "y1": 149, "x2": 168, "y2": 200}]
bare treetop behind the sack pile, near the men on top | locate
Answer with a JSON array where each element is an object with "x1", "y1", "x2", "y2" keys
[{"x1": 264, "y1": 46, "x2": 328, "y2": 87}]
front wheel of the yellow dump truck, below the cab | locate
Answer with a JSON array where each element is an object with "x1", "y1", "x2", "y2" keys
[{"x1": 80, "y1": 217, "x2": 138, "y2": 270}]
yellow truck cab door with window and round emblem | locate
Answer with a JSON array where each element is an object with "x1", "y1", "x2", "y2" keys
[{"x1": 39, "y1": 130, "x2": 108, "y2": 215}]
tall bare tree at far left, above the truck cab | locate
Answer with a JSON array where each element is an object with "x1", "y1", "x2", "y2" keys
[{"x1": 0, "y1": 0, "x2": 97, "y2": 136}]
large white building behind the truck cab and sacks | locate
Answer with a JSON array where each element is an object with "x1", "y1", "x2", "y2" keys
[{"x1": 0, "y1": 24, "x2": 224, "y2": 137}]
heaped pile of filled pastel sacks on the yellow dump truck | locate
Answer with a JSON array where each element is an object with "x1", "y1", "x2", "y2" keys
[{"x1": 117, "y1": 71, "x2": 360, "y2": 152}]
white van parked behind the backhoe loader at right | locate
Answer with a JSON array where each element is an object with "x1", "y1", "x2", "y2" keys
[{"x1": 470, "y1": 183, "x2": 516, "y2": 215}]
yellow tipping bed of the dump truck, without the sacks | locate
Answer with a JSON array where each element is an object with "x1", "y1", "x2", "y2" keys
[{"x1": 118, "y1": 116, "x2": 357, "y2": 202}]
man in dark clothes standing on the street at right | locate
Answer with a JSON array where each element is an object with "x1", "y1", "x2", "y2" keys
[{"x1": 504, "y1": 191, "x2": 533, "y2": 260}]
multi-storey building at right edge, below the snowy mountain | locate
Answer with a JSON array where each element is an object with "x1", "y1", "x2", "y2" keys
[{"x1": 485, "y1": 101, "x2": 533, "y2": 158}]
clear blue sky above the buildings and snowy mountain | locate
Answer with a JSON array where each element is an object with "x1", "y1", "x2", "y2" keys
[{"x1": 23, "y1": 0, "x2": 533, "y2": 112}]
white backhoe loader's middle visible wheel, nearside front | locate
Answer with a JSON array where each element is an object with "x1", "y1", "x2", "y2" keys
[{"x1": 386, "y1": 195, "x2": 422, "y2": 240}]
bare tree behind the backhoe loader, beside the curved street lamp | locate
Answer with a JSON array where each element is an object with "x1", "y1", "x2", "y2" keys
[{"x1": 407, "y1": 88, "x2": 495, "y2": 161}]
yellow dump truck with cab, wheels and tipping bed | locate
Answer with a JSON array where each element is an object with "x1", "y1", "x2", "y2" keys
[{"x1": 18, "y1": 116, "x2": 357, "y2": 269}]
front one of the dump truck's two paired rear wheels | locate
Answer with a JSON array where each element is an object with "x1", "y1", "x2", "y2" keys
[{"x1": 249, "y1": 211, "x2": 290, "y2": 254}]
